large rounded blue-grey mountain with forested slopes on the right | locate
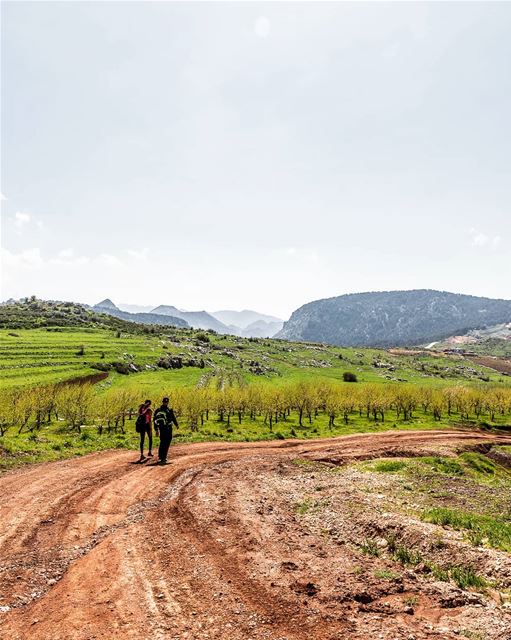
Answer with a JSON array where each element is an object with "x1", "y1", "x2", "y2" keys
[{"x1": 275, "y1": 289, "x2": 511, "y2": 347}]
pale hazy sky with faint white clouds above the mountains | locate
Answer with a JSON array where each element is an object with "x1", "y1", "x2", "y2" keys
[{"x1": 0, "y1": 1, "x2": 511, "y2": 318}]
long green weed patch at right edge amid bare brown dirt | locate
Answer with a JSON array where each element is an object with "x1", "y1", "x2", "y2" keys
[{"x1": 421, "y1": 507, "x2": 511, "y2": 553}]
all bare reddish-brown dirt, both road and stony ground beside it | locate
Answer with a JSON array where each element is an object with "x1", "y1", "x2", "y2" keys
[{"x1": 0, "y1": 431, "x2": 511, "y2": 640}]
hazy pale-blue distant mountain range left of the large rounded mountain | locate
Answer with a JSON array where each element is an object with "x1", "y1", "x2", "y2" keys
[{"x1": 93, "y1": 298, "x2": 283, "y2": 338}]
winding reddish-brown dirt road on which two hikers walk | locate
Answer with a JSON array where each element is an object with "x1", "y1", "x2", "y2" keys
[{"x1": 0, "y1": 431, "x2": 511, "y2": 640}]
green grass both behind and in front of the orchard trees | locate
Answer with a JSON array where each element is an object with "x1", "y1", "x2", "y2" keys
[{"x1": 0, "y1": 327, "x2": 511, "y2": 468}]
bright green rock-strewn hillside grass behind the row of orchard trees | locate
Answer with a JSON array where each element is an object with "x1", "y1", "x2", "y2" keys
[{"x1": 0, "y1": 328, "x2": 511, "y2": 388}]
